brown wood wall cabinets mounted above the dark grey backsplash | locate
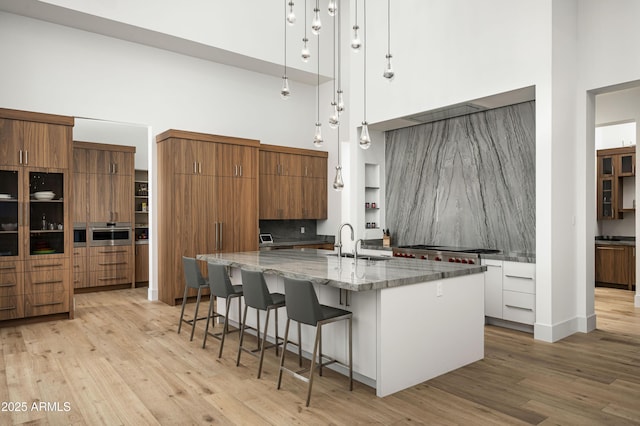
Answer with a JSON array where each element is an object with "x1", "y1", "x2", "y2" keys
[{"x1": 260, "y1": 145, "x2": 328, "y2": 219}]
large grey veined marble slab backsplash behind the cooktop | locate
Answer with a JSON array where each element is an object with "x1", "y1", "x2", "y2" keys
[{"x1": 385, "y1": 101, "x2": 535, "y2": 253}]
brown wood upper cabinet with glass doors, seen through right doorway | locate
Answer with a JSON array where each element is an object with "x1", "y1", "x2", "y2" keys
[{"x1": 596, "y1": 146, "x2": 636, "y2": 220}]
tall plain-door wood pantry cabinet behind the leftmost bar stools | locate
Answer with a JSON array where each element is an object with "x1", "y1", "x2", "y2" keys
[{"x1": 156, "y1": 130, "x2": 260, "y2": 305}]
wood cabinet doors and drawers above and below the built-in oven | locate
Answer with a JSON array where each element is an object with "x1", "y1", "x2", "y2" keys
[{"x1": 73, "y1": 141, "x2": 135, "y2": 291}]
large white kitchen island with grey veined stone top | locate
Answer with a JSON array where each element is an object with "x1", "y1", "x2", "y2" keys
[{"x1": 197, "y1": 249, "x2": 486, "y2": 397}]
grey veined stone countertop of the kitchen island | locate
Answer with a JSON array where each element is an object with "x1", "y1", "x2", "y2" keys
[{"x1": 197, "y1": 249, "x2": 487, "y2": 291}]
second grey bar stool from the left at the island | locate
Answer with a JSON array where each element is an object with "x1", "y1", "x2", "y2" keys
[{"x1": 202, "y1": 263, "x2": 242, "y2": 358}]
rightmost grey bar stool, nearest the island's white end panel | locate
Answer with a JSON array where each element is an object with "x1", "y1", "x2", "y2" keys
[{"x1": 278, "y1": 278, "x2": 353, "y2": 407}]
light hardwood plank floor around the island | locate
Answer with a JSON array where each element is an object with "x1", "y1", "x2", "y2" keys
[{"x1": 0, "y1": 288, "x2": 640, "y2": 425}]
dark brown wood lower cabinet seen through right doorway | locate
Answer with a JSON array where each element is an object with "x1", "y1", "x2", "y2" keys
[{"x1": 595, "y1": 244, "x2": 636, "y2": 290}]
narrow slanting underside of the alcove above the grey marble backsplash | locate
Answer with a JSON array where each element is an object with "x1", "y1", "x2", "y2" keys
[{"x1": 369, "y1": 86, "x2": 536, "y2": 132}]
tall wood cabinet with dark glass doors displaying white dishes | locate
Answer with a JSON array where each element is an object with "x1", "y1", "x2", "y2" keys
[{"x1": 0, "y1": 109, "x2": 74, "y2": 326}]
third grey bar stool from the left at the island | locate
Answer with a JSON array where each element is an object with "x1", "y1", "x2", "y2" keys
[{"x1": 236, "y1": 269, "x2": 284, "y2": 378}]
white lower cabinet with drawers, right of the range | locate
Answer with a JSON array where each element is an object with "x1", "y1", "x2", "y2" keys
[{"x1": 483, "y1": 259, "x2": 536, "y2": 325}]
